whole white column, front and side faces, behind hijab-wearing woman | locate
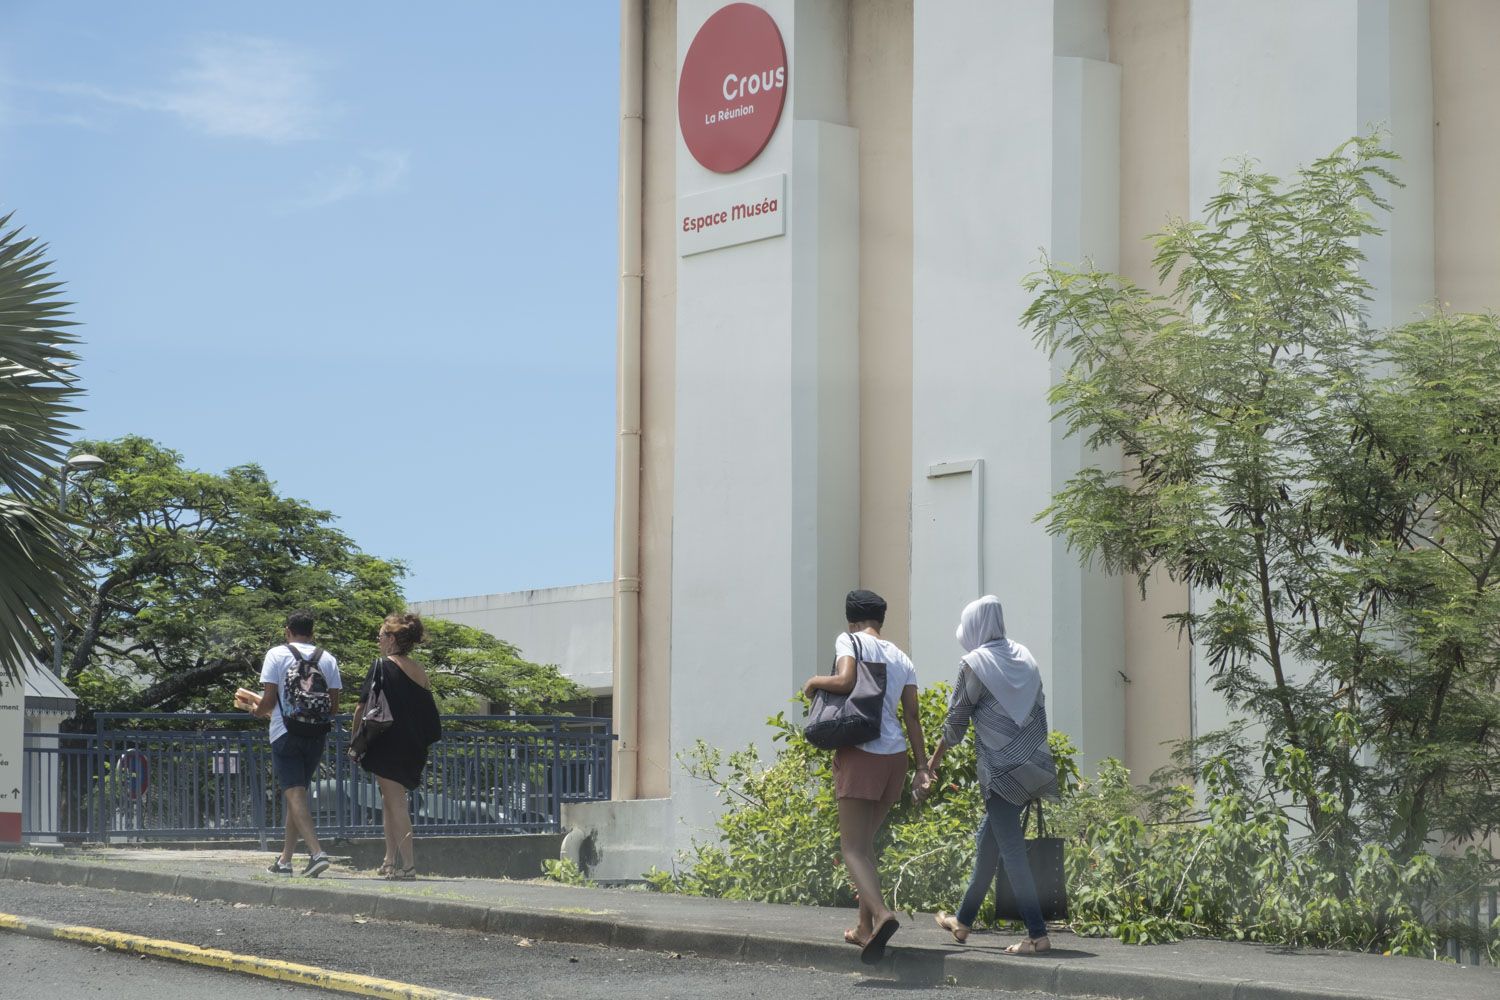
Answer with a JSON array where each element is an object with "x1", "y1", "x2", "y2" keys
[{"x1": 912, "y1": 0, "x2": 1124, "y2": 759}]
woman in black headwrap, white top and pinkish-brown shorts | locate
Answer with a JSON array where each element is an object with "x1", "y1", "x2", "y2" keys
[{"x1": 803, "y1": 591, "x2": 932, "y2": 966}]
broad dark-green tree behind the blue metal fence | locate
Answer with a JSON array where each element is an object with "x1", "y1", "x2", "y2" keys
[{"x1": 54, "y1": 436, "x2": 581, "y2": 712}]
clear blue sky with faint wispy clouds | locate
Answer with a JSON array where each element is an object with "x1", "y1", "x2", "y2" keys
[{"x1": 0, "y1": 0, "x2": 620, "y2": 600}]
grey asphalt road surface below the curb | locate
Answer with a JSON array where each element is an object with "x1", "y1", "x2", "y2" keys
[{"x1": 0, "y1": 880, "x2": 1080, "y2": 1000}]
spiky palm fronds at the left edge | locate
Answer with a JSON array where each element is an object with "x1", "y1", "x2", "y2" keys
[{"x1": 0, "y1": 214, "x2": 80, "y2": 678}]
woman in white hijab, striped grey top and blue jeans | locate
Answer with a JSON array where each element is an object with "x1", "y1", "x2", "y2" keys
[{"x1": 924, "y1": 597, "x2": 1058, "y2": 955}]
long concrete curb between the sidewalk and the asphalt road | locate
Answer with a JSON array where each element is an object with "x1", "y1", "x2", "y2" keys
[{"x1": 0, "y1": 853, "x2": 1434, "y2": 1000}]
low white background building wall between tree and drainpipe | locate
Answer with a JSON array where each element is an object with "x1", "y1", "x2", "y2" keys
[{"x1": 410, "y1": 583, "x2": 614, "y2": 696}]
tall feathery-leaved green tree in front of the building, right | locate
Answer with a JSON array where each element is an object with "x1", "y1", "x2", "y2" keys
[{"x1": 1025, "y1": 138, "x2": 1500, "y2": 869}]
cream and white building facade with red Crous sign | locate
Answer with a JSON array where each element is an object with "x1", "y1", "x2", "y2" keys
[{"x1": 602, "y1": 0, "x2": 1500, "y2": 875}]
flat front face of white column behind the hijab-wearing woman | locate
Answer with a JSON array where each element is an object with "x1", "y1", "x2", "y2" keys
[{"x1": 911, "y1": 0, "x2": 1053, "y2": 687}]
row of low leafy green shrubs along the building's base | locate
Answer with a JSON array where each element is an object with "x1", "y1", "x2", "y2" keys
[{"x1": 647, "y1": 685, "x2": 1500, "y2": 960}]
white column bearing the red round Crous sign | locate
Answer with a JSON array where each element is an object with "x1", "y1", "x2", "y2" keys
[{"x1": 671, "y1": 0, "x2": 860, "y2": 846}]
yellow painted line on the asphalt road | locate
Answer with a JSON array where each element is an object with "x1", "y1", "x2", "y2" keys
[{"x1": 0, "y1": 913, "x2": 483, "y2": 1000}]
